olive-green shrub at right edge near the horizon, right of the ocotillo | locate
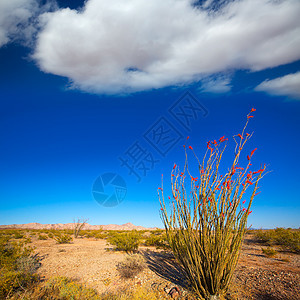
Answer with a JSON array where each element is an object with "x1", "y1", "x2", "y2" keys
[{"x1": 255, "y1": 228, "x2": 300, "y2": 253}]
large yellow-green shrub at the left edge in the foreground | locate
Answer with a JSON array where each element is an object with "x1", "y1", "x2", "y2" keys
[{"x1": 0, "y1": 238, "x2": 40, "y2": 299}]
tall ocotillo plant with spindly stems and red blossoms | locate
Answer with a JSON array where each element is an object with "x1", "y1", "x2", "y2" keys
[{"x1": 158, "y1": 108, "x2": 266, "y2": 299}]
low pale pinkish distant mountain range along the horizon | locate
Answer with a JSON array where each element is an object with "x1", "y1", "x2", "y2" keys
[{"x1": 0, "y1": 223, "x2": 158, "y2": 230}]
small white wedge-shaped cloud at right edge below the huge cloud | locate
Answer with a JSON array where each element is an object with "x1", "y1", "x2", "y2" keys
[{"x1": 255, "y1": 72, "x2": 300, "y2": 99}]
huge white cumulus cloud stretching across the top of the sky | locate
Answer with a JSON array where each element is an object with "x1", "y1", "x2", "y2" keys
[{"x1": 33, "y1": 0, "x2": 300, "y2": 94}]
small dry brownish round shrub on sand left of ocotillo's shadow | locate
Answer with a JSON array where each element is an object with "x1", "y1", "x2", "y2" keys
[{"x1": 117, "y1": 254, "x2": 146, "y2": 279}]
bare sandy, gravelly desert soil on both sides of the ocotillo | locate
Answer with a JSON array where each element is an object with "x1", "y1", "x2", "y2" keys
[{"x1": 33, "y1": 235, "x2": 300, "y2": 300}]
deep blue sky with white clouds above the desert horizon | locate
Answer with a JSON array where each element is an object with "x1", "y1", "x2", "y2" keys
[{"x1": 0, "y1": 0, "x2": 300, "y2": 228}]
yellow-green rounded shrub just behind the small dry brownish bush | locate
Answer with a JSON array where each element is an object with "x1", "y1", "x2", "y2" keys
[{"x1": 108, "y1": 231, "x2": 141, "y2": 252}]
